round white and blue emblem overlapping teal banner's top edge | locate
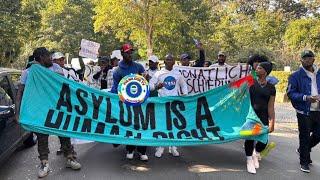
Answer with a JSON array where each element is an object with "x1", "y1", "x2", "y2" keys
[{"x1": 118, "y1": 74, "x2": 150, "y2": 106}]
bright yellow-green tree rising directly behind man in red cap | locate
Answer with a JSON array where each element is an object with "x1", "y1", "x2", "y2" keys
[{"x1": 94, "y1": 0, "x2": 184, "y2": 55}]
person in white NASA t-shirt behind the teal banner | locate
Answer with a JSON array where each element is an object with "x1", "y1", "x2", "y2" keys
[{"x1": 149, "y1": 54, "x2": 188, "y2": 158}]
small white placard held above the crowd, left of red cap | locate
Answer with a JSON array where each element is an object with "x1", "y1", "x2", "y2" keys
[{"x1": 79, "y1": 39, "x2": 100, "y2": 59}]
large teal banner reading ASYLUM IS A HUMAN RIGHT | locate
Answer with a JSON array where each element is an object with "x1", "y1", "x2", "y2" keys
[{"x1": 20, "y1": 65, "x2": 268, "y2": 146}]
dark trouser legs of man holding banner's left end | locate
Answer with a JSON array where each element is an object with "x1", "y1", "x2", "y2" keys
[{"x1": 36, "y1": 133, "x2": 73, "y2": 161}]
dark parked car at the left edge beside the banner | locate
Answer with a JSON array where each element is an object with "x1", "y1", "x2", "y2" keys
[{"x1": 0, "y1": 68, "x2": 36, "y2": 164}]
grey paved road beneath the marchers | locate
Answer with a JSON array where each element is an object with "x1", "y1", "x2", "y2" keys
[{"x1": 0, "y1": 104, "x2": 320, "y2": 180}]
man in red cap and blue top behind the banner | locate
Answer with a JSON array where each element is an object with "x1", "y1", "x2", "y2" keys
[{"x1": 111, "y1": 44, "x2": 148, "y2": 161}]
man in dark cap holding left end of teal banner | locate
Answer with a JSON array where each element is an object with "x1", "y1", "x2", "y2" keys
[{"x1": 16, "y1": 47, "x2": 81, "y2": 178}]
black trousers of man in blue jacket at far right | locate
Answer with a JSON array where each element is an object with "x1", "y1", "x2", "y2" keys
[{"x1": 297, "y1": 111, "x2": 320, "y2": 165}]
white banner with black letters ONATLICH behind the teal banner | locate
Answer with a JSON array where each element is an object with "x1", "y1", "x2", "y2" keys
[{"x1": 174, "y1": 64, "x2": 251, "y2": 94}]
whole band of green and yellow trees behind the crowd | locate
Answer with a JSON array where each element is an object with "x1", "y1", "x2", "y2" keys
[{"x1": 0, "y1": 0, "x2": 320, "y2": 69}]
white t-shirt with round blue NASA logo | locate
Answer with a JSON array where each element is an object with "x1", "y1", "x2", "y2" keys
[{"x1": 149, "y1": 68, "x2": 188, "y2": 97}]
